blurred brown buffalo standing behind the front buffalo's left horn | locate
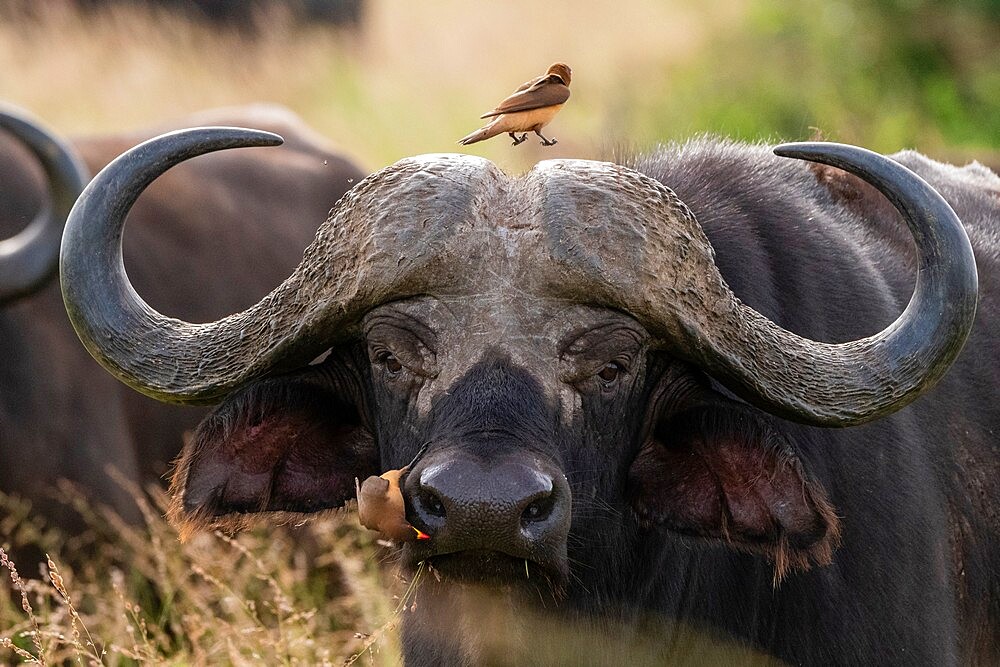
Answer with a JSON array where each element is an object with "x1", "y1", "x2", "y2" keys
[{"x1": 0, "y1": 106, "x2": 363, "y2": 529}]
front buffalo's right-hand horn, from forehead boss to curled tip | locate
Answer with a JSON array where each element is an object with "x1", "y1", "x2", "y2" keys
[{"x1": 529, "y1": 143, "x2": 978, "y2": 426}]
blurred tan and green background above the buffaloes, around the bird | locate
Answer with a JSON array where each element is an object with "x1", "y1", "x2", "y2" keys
[{"x1": 0, "y1": 0, "x2": 1000, "y2": 171}]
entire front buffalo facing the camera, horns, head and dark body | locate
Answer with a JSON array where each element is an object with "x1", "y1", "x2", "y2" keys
[{"x1": 61, "y1": 129, "x2": 1000, "y2": 665}]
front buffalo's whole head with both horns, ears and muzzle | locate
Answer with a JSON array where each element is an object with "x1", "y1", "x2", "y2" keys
[{"x1": 56, "y1": 128, "x2": 977, "y2": 652}]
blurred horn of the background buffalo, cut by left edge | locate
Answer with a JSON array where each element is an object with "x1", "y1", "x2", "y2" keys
[{"x1": 0, "y1": 105, "x2": 90, "y2": 306}]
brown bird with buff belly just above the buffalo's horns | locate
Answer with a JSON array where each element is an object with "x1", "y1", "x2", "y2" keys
[{"x1": 458, "y1": 63, "x2": 572, "y2": 146}]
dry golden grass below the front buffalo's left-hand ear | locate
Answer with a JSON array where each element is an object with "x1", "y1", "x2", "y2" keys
[{"x1": 0, "y1": 482, "x2": 405, "y2": 665}]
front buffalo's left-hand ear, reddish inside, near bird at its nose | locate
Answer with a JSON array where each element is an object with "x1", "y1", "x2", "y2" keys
[{"x1": 168, "y1": 370, "x2": 378, "y2": 538}]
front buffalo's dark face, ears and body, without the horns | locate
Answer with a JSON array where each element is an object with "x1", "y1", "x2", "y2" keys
[{"x1": 160, "y1": 142, "x2": 1000, "y2": 664}]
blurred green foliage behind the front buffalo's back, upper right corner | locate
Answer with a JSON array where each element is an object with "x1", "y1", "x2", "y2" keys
[{"x1": 642, "y1": 0, "x2": 1000, "y2": 155}]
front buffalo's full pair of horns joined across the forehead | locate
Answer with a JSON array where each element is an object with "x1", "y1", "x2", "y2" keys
[{"x1": 62, "y1": 129, "x2": 977, "y2": 426}]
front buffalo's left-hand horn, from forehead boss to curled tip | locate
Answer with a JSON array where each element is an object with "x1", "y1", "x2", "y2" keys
[{"x1": 60, "y1": 128, "x2": 502, "y2": 403}]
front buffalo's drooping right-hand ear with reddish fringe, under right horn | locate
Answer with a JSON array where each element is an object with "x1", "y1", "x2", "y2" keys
[{"x1": 629, "y1": 397, "x2": 840, "y2": 583}]
